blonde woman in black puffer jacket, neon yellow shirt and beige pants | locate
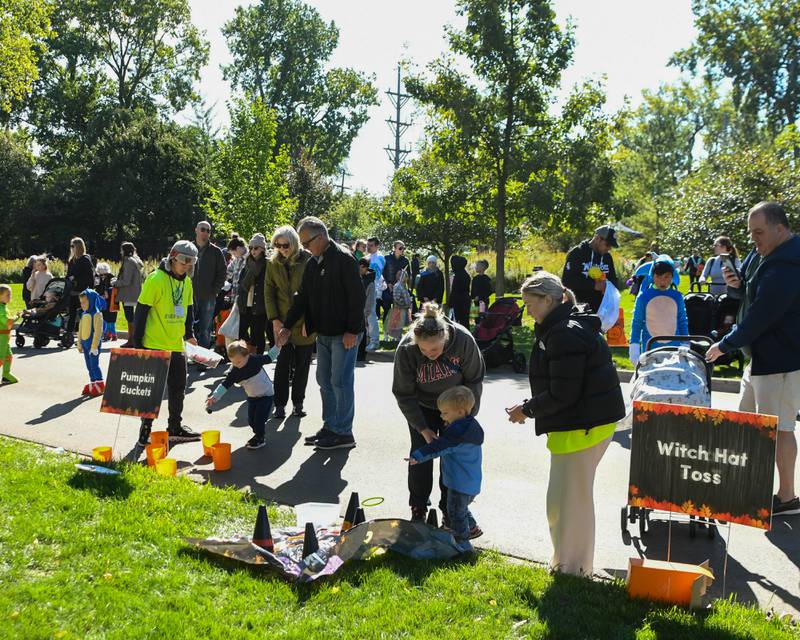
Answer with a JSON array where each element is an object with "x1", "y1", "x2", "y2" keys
[{"x1": 506, "y1": 271, "x2": 625, "y2": 575}]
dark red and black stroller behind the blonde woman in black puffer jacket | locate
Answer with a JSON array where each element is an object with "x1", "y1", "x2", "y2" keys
[{"x1": 473, "y1": 297, "x2": 528, "y2": 373}]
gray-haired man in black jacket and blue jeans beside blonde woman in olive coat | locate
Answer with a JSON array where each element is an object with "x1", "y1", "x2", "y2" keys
[{"x1": 276, "y1": 216, "x2": 366, "y2": 450}]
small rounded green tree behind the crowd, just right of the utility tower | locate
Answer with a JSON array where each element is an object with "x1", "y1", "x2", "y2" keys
[{"x1": 378, "y1": 148, "x2": 494, "y2": 296}]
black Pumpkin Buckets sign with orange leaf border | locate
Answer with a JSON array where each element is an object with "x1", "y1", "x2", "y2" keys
[{"x1": 100, "y1": 349, "x2": 171, "y2": 419}]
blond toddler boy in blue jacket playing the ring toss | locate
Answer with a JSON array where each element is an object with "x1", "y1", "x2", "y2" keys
[{"x1": 406, "y1": 386, "x2": 483, "y2": 553}]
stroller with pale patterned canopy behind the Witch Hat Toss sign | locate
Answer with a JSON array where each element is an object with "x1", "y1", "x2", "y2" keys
[{"x1": 620, "y1": 336, "x2": 714, "y2": 544}]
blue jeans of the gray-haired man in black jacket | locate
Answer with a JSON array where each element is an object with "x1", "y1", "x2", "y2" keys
[{"x1": 317, "y1": 335, "x2": 361, "y2": 436}]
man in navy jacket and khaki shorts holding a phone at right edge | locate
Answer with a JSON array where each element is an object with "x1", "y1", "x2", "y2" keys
[{"x1": 706, "y1": 201, "x2": 800, "y2": 516}]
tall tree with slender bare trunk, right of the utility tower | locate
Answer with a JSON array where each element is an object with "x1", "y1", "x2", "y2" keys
[{"x1": 406, "y1": 0, "x2": 610, "y2": 295}]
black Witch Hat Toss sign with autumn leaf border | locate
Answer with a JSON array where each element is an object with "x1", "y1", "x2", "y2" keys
[{"x1": 628, "y1": 400, "x2": 778, "y2": 529}]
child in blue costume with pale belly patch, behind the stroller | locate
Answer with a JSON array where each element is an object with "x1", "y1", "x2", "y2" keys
[{"x1": 629, "y1": 255, "x2": 689, "y2": 366}]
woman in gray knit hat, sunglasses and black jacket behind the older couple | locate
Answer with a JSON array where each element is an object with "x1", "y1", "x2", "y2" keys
[{"x1": 236, "y1": 233, "x2": 267, "y2": 355}]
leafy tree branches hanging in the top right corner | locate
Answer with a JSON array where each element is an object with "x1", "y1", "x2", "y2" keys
[{"x1": 672, "y1": 0, "x2": 800, "y2": 136}]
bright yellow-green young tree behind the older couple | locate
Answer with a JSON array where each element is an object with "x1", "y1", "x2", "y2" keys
[{"x1": 206, "y1": 98, "x2": 294, "y2": 236}]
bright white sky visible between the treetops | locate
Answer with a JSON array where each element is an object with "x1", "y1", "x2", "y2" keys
[{"x1": 184, "y1": 0, "x2": 695, "y2": 193}]
